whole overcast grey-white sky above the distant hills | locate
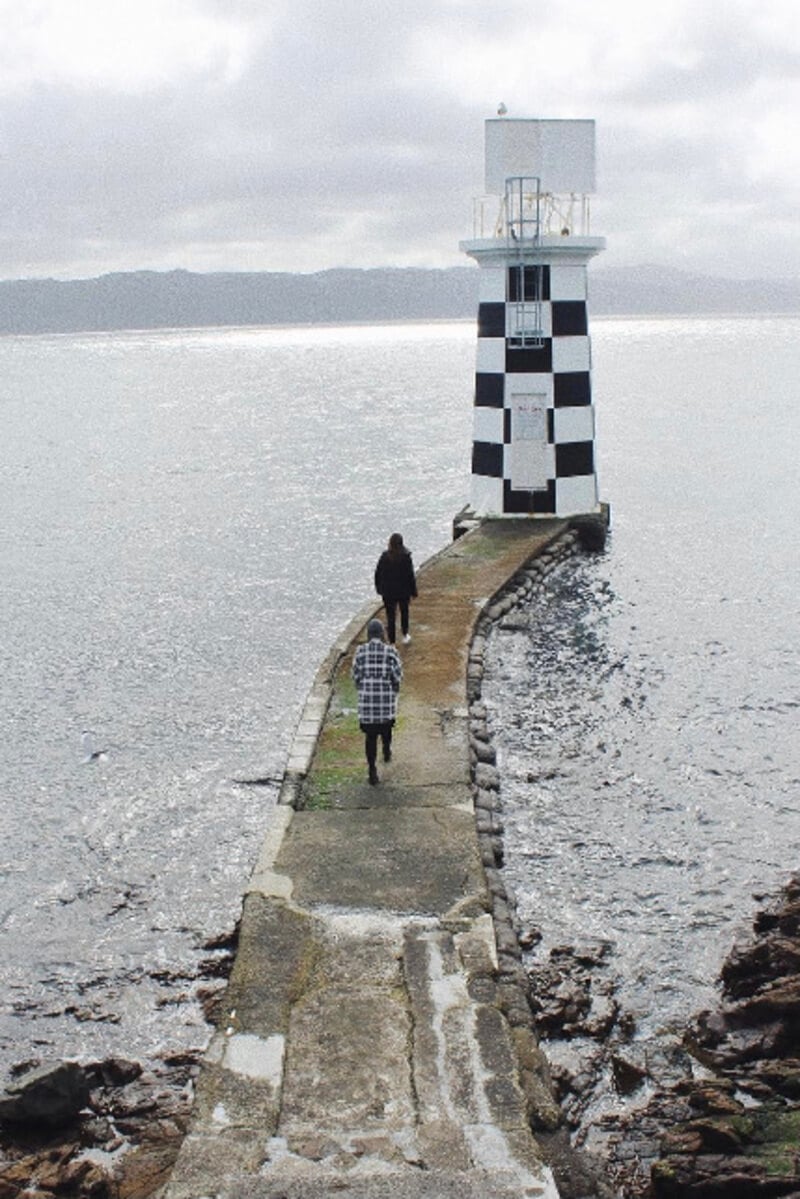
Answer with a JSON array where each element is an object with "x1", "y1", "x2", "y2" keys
[{"x1": 0, "y1": 0, "x2": 800, "y2": 278}]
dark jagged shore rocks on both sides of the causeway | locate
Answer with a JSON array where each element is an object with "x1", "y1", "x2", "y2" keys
[{"x1": 7, "y1": 872, "x2": 800, "y2": 1199}]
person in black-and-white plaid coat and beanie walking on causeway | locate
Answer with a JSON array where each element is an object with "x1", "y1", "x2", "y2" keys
[{"x1": 353, "y1": 620, "x2": 403, "y2": 783}]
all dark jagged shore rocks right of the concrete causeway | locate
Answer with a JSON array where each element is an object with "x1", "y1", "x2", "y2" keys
[{"x1": 522, "y1": 875, "x2": 800, "y2": 1199}]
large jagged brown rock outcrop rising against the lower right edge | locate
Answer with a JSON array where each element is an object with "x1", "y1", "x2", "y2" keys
[{"x1": 604, "y1": 876, "x2": 800, "y2": 1199}]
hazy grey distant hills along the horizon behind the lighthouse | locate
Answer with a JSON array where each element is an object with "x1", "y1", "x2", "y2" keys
[{"x1": 0, "y1": 266, "x2": 800, "y2": 333}]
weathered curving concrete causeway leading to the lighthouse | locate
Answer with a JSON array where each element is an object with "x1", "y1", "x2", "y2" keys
[{"x1": 166, "y1": 519, "x2": 566, "y2": 1199}]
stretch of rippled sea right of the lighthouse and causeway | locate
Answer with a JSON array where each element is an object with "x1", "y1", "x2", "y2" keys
[{"x1": 483, "y1": 318, "x2": 800, "y2": 1119}]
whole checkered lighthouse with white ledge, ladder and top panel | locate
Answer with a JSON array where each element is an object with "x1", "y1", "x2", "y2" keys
[{"x1": 461, "y1": 118, "x2": 604, "y2": 517}]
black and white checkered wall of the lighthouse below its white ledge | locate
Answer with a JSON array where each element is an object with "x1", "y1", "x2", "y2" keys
[{"x1": 471, "y1": 254, "x2": 599, "y2": 516}]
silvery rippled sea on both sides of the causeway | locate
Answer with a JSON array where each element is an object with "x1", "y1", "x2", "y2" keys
[{"x1": 0, "y1": 318, "x2": 800, "y2": 1122}]
